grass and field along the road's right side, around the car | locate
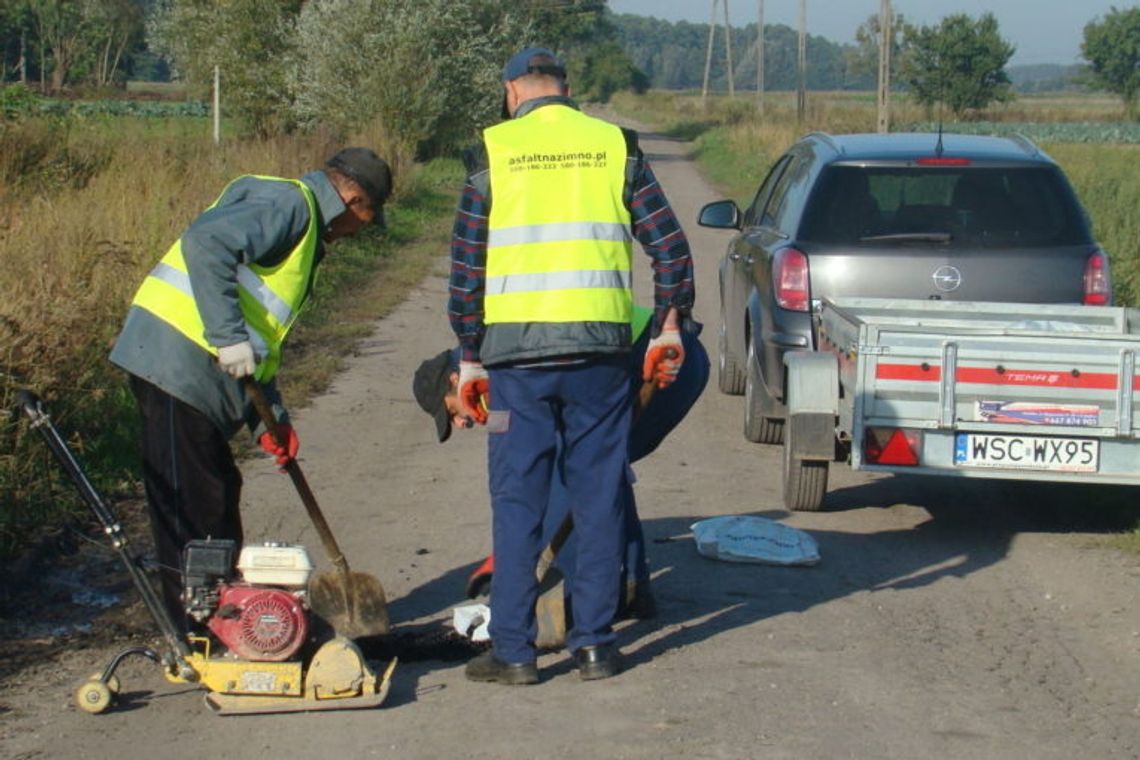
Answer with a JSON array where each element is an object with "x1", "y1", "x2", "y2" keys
[{"x1": 611, "y1": 92, "x2": 1140, "y2": 546}]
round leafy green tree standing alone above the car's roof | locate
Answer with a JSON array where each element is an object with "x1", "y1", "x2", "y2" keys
[{"x1": 899, "y1": 14, "x2": 1015, "y2": 116}]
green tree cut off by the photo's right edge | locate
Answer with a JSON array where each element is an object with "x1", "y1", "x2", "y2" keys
[{"x1": 1081, "y1": 7, "x2": 1140, "y2": 117}]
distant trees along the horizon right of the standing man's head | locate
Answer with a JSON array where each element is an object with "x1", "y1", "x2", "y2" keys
[{"x1": 614, "y1": 7, "x2": 1140, "y2": 115}]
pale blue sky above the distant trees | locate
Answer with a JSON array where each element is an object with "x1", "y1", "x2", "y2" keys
[{"x1": 609, "y1": 0, "x2": 1137, "y2": 66}]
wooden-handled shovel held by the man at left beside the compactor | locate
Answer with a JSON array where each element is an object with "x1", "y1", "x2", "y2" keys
[{"x1": 245, "y1": 377, "x2": 390, "y2": 638}]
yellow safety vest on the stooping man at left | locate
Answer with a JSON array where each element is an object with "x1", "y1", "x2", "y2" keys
[{"x1": 132, "y1": 177, "x2": 320, "y2": 383}]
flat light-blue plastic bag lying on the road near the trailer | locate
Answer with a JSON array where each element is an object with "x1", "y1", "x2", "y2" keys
[{"x1": 691, "y1": 515, "x2": 820, "y2": 565}]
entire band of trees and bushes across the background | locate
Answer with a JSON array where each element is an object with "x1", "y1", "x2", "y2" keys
[{"x1": 0, "y1": 0, "x2": 1140, "y2": 137}]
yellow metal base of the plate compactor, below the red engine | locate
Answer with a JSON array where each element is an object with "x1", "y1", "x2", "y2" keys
[{"x1": 168, "y1": 637, "x2": 396, "y2": 716}]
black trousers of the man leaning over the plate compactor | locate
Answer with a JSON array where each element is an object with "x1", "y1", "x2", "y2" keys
[{"x1": 130, "y1": 376, "x2": 242, "y2": 630}]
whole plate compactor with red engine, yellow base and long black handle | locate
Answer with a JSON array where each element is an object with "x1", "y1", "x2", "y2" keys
[{"x1": 17, "y1": 391, "x2": 396, "y2": 714}]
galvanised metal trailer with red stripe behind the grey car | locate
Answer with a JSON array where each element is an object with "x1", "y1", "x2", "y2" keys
[{"x1": 783, "y1": 297, "x2": 1140, "y2": 512}]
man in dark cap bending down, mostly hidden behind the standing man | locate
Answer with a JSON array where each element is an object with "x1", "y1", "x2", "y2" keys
[{"x1": 413, "y1": 307, "x2": 709, "y2": 647}]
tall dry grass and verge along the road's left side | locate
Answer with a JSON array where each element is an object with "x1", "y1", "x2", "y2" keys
[{"x1": 0, "y1": 116, "x2": 462, "y2": 559}]
